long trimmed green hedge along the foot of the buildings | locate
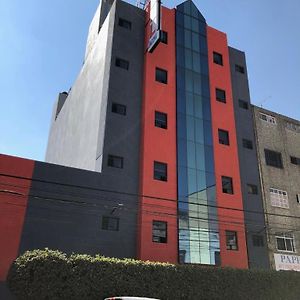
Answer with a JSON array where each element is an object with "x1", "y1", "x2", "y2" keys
[{"x1": 7, "y1": 249, "x2": 300, "y2": 300}]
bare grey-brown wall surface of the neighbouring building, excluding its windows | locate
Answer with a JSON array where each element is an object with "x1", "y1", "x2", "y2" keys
[{"x1": 253, "y1": 107, "x2": 300, "y2": 268}]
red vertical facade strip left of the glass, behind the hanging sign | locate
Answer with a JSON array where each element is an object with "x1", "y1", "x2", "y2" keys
[{"x1": 137, "y1": 8, "x2": 178, "y2": 263}]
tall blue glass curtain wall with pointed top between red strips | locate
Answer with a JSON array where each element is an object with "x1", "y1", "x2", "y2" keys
[{"x1": 176, "y1": 1, "x2": 220, "y2": 265}]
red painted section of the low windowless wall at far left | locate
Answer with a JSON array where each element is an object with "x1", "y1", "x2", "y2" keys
[{"x1": 0, "y1": 155, "x2": 34, "y2": 281}]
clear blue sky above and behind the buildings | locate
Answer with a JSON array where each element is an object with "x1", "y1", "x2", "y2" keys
[{"x1": 0, "y1": 0, "x2": 300, "y2": 161}]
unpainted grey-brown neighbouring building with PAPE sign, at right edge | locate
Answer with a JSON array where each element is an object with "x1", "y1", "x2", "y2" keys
[{"x1": 253, "y1": 106, "x2": 300, "y2": 271}]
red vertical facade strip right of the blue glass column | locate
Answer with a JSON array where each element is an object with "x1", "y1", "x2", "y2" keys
[{"x1": 207, "y1": 27, "x2": 248, "y2": 268}]
